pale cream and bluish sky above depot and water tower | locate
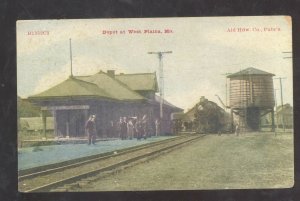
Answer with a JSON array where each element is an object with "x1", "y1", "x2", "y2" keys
[{"x1": 17, "y1": 16, "x2": 293, "y2": 111}]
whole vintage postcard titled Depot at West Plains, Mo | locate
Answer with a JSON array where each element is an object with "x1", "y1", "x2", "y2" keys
[{"x1": 17, "y1": 16, "x2": 294, "y2": 192}]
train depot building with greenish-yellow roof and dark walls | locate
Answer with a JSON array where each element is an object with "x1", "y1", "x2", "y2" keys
[{"x1": 28, "y1": 70, "x2": 183, "y2": 137}]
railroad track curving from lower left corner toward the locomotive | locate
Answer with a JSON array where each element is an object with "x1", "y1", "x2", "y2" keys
[{"x1": 18, "y1": 135, "x2": 204, "y2": 192}]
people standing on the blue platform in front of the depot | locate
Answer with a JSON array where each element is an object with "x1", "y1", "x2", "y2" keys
[{"x1": 85, "y1": 115, "x2": 160, "y2": 145}]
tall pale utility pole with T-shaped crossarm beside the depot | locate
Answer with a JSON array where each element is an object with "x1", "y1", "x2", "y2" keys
[{"x1": 148, "y1": 51, "x2": 172, "y2": 120}]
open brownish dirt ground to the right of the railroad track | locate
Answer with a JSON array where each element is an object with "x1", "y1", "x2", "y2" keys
[{"x1": 82, "y1": 133, "x2": 294, "y2": 191}]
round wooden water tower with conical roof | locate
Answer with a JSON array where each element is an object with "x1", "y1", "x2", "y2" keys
[{"x1": 227, "y1": 67, "x2": 275, "y2": 131}]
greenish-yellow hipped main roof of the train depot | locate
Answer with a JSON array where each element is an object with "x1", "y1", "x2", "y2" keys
[{"x1": 28, "y1": 71, "x2": 158, "y2": 101}]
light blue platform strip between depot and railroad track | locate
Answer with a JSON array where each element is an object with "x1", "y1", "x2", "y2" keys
[{"x1": 18, "y1": 136, "x2": 175, "y2": 170}]
